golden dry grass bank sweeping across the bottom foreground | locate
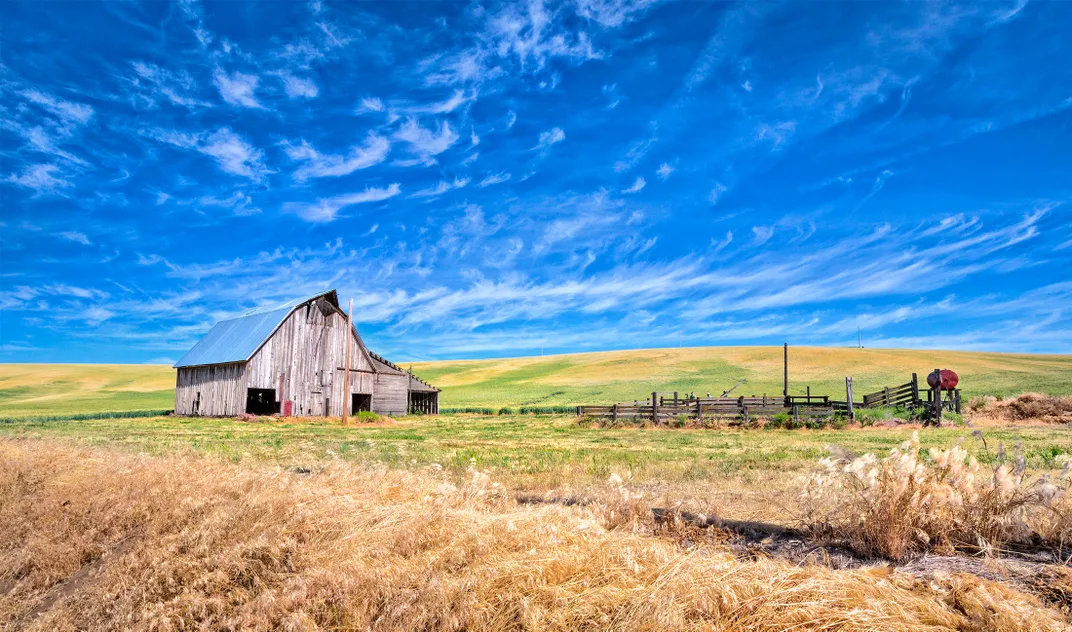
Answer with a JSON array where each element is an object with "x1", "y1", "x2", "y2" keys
[{"x1": 0, "y1": 440, "x2": 1069, "y2": 631}]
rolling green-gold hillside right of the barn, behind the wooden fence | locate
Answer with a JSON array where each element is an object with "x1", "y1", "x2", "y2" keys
[{"x1": 413, "y1": 347, "x2": 1072, "y2": 406}]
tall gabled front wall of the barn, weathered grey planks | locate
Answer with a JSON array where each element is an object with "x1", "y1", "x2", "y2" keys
[{"x1": 248, "y1": 302, "x2": 376, "y2": 416}]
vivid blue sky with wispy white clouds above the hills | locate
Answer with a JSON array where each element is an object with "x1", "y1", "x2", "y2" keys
[{"x1": 0, "y1": 0, "x2": 1072, "y2": 362}]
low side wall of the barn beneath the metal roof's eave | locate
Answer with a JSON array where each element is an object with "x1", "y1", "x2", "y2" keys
[{"x1": 175, "y1": 362, "x2": 245, "y2": 417}]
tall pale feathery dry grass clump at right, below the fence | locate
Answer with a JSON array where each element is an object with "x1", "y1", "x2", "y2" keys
[{"x1": 802, "y1": 433, "x2": 1072, "y2": 560}]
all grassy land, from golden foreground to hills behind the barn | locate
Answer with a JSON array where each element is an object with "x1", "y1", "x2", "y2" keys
[{"x1": 0, "y1": 348, "x2": 1072, "y2": 631}]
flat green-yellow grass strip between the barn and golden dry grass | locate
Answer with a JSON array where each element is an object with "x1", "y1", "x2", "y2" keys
[{"x1": 0, "y1": 416, "x2": 1072, "y2": 487}]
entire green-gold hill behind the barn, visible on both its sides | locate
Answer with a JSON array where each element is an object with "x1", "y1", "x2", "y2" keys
[{"x1": 0, "y1": 347, "x2": 1072, "y2": 417}]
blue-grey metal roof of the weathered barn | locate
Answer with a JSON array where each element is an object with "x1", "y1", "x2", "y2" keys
[{"x1": 175, "y1": 290, "x2": 339, "y2": 368}]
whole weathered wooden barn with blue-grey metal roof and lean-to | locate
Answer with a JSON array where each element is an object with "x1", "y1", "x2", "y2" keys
[{"x1": 175, "y1": 290, "x2": 440, "y2": 417}]
